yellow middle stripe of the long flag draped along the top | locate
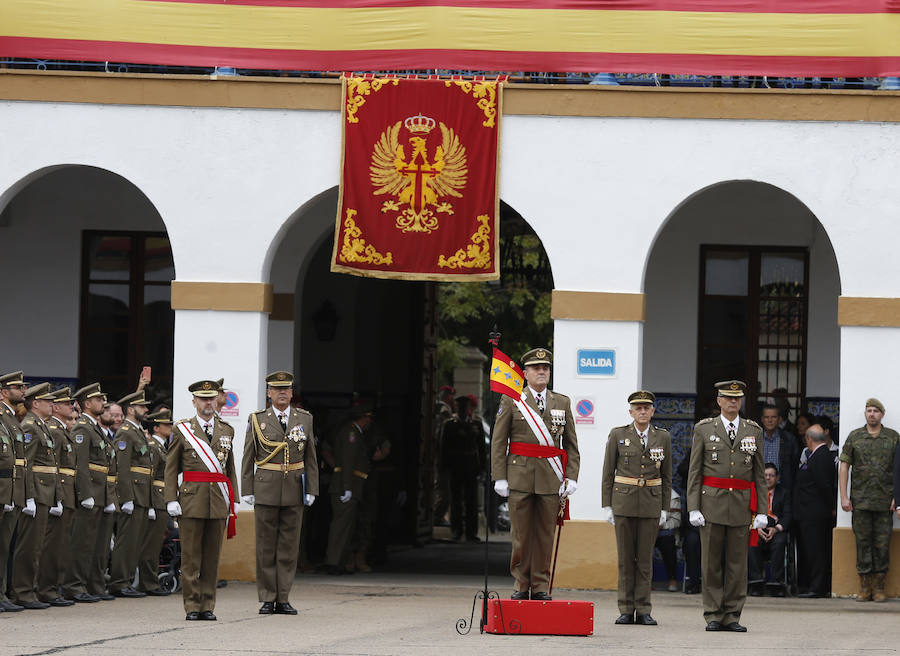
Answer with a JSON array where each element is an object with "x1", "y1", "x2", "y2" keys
[{"x1": 0, "y1": 0, "x2": 900, "y2": 57}]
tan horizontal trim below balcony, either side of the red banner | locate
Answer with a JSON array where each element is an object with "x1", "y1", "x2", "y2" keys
[{"x1": 0, "y1": 69, "x2": 900, "y2": 123}]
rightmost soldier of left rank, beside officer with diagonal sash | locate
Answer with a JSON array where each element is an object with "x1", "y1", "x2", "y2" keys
[{"x1": 138, "y1": 408, "x2": 172, "y2": 597}]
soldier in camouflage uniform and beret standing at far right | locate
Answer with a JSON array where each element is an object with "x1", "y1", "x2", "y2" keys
[{"x1": 838, "y1": 399, "x2": 900, "y2": 601}]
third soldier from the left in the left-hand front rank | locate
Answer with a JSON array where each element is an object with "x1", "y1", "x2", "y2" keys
[{"x1": 38, "y1": 387, "x2": 75, "y2": 606}]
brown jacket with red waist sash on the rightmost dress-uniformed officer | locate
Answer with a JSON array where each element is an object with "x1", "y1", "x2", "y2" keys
[{"x1": 687, "y1": 416, "x2": 768, "y2": 526}]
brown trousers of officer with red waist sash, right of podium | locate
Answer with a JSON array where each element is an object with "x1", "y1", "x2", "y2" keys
[{"x1": 700, "y1": 522, "x2": 750, "y2": 624}]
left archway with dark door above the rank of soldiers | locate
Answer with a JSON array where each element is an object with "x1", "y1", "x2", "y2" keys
[{"x1": 0, "y1": 165, "x2": 175, "y2": 403}]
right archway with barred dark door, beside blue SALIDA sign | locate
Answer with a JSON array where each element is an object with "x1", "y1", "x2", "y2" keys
[{"x1": 642, "y1": 180, "x2": 840, "y2": 464}]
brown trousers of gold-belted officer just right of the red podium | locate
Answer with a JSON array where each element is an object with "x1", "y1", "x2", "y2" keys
[{"x1": 616, "y1": 515, "x2": 659, "y2": 615}]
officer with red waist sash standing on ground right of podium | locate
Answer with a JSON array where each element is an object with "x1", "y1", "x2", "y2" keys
[{"x1": 687, "y1": 380, "x2": 768, "y2": 632}]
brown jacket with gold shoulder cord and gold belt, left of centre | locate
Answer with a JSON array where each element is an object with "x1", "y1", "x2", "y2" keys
[{"x1": 241, "y1": 407, "x2": 320, "y2": 506}]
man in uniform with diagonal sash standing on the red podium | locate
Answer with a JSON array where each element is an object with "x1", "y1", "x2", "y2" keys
[{"x1": 491, "y1": 348, "x2": 581, "y2": 600}]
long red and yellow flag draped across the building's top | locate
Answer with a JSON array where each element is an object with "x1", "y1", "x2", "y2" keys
[{"x1": 0, "y1": 0, "x2": 900, "y2": 77}]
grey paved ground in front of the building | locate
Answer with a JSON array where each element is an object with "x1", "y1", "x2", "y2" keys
[{"x1": 0, "y1": 545, "x2": 900, "y2": 656}]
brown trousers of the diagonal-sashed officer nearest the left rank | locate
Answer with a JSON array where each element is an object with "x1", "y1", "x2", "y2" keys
[{"x1": 178, "y1": 517, "x2": 228, "y2": 613}]
